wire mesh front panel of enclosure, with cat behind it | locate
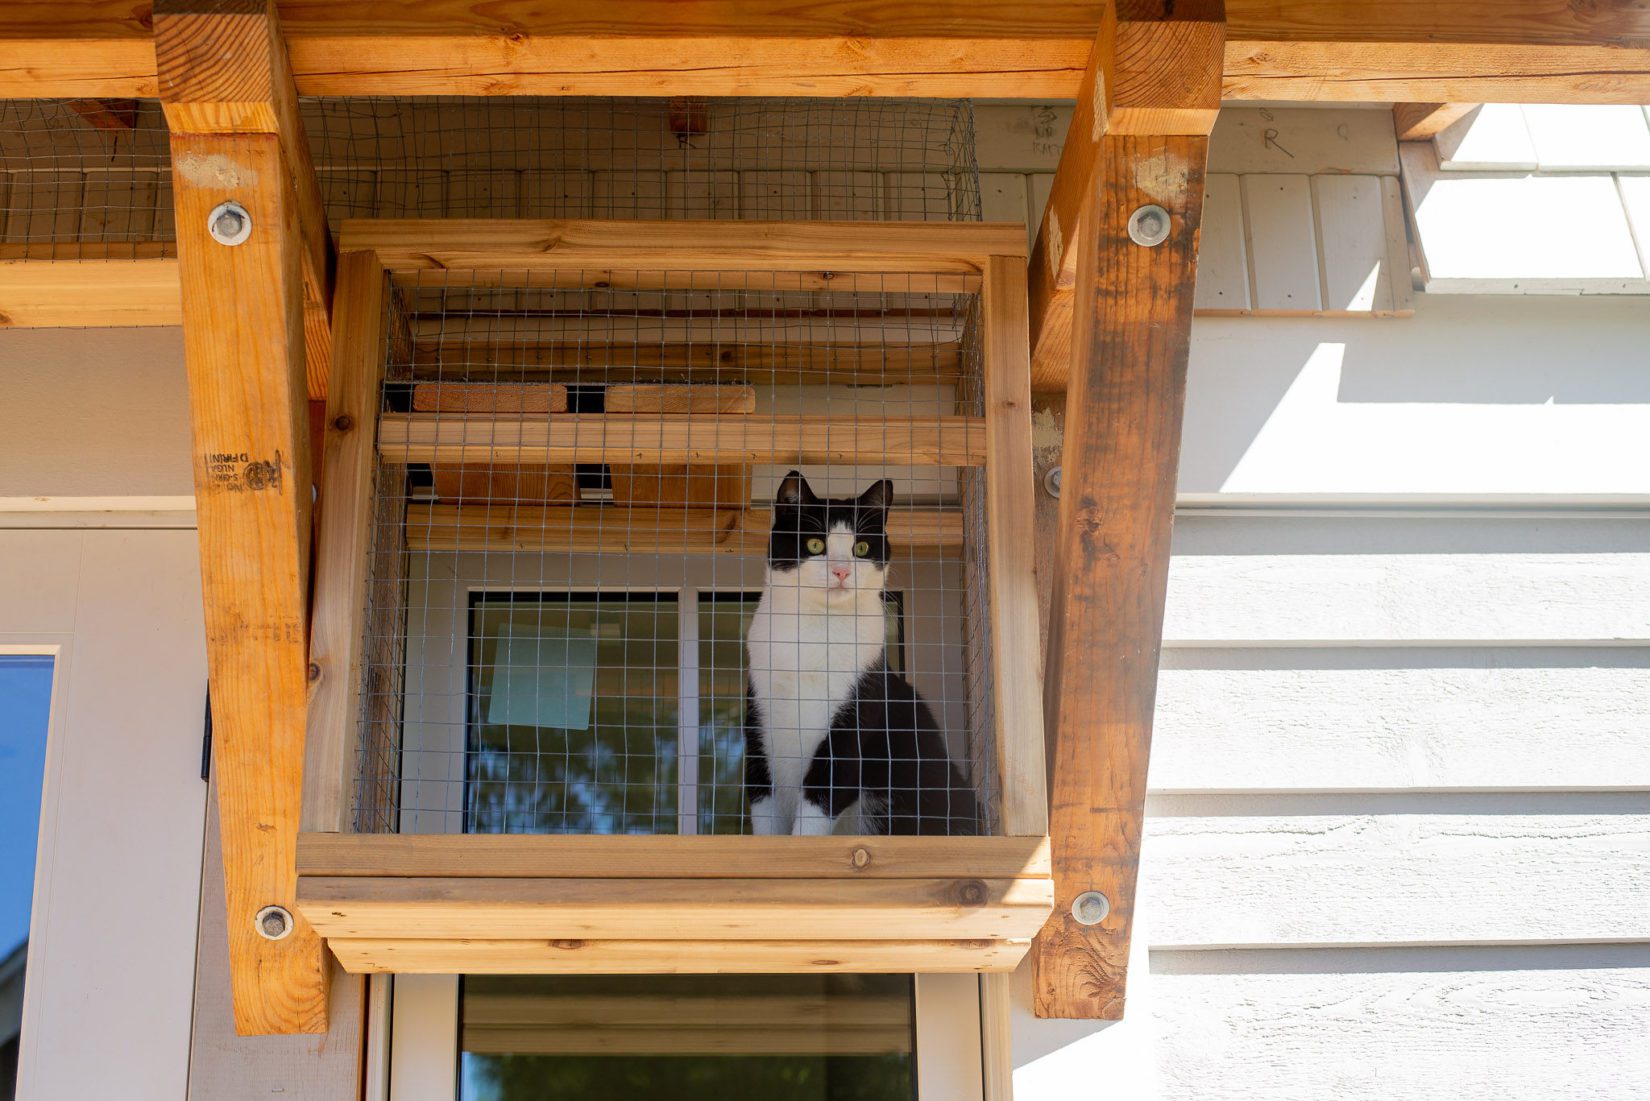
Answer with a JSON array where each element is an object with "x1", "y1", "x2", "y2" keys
[{"x1": 356, "y1": 269, "x2": 997, "y2": 834}]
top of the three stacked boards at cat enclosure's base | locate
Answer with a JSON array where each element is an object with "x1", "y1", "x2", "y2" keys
[{"x1": 299, "y1": 834, "x2": 1049, "y2": 880}]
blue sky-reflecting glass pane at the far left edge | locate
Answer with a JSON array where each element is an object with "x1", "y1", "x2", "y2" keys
[{"x1": 0, "y1": 654, "x2": 53, "y2": 1098}]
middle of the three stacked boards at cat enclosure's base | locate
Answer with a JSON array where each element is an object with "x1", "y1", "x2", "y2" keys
[{"x1": 299, "y1": 868, "x2": 1053, "y2": 941}]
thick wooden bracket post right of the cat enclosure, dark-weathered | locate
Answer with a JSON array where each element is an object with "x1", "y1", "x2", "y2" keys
[{"x1": 1031, "y1": 2, "x2": 1224, "y2": 1020}]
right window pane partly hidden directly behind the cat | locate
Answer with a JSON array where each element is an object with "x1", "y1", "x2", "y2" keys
[{"x1": 698, "y1": 593, "x2": 904, "y2": 834}]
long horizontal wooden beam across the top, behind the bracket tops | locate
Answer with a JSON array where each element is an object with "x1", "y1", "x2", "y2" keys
[{"x1": 0, "y1": 0, "x2": 1650, "y2": 104}]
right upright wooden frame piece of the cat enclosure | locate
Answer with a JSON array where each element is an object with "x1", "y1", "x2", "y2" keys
[{"x1": 980, "y1": 256, "x2": 1048, "y2": 837}]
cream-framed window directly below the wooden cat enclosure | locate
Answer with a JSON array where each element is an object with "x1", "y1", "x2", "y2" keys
[{"x1": 384, "y1": 974, "x2": 983, "y2": 1101}]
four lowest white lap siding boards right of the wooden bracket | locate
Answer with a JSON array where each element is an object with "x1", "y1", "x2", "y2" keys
[{"x1": 1130, "y1": 502, "x2": 1650, "y2": 1101}]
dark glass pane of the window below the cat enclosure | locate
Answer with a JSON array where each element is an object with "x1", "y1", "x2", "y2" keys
[{"x1": 459, "y1": 976, "x2": 916, "y2": 1101}]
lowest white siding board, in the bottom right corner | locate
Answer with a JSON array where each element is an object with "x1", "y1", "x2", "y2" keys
[{"x1": 1152, "y1": 946, "x2": 1650, "y2": 1101}]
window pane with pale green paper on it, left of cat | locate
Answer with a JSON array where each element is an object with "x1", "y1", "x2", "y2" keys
[{"x1": 465, "y1": 593, "x2": 680, "y2": 834}]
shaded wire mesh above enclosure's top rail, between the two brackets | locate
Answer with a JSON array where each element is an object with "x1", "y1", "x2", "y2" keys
[{"x1": 304, "y1": 96, "x2": 980, "y2": 223}]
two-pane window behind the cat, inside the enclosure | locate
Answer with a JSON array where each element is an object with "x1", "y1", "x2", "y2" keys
[{"x1": 464, "y1": 591, "x2": 904, "y2": 834}]
